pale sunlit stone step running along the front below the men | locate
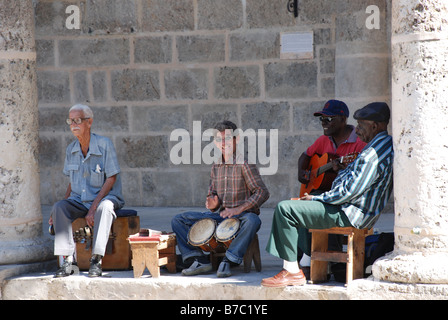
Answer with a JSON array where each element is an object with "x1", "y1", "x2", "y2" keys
[{"x1": 1, "y1": 266, "x2": 448, "y2": 302}]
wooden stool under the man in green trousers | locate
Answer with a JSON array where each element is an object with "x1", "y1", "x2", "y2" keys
[{"x1": 310, "y1": 227, "x2": 371, "y2": 284}]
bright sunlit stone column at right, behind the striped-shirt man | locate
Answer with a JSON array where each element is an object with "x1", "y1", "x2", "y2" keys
[{"x1": 373, "y1": 0, "x2": 448, "y2": 284}]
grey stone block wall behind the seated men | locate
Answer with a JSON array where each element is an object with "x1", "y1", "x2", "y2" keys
[{"x1": 34, "y1": 0, "x2": 390, "y2": 206}]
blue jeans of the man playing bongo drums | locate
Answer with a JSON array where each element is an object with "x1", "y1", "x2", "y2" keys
[{"x1": 171, "y1": 211, "x2": 261, "y2": 264}]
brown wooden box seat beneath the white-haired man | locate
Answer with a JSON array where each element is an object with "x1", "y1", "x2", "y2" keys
[{"x1": 72, "y1": 210, "x2": 140, "y2": 270}]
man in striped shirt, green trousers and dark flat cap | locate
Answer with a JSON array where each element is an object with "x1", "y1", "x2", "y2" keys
[{"x1": 261, "y1": 102, "x2": 394, "y2": 287}]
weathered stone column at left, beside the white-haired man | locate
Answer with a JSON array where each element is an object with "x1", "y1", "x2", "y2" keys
[{"x1": 0, "y1": 0, "x2": 51, "y2": 266}]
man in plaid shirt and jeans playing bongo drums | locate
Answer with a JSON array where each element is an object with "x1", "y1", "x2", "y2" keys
[{"x1": 171, "y1": 121, "x2": 269, "y2": 277}]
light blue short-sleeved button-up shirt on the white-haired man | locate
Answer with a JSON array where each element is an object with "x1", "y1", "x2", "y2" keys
[{"x1": 63, "y1": 133, "x2": 124, "y2": 209}]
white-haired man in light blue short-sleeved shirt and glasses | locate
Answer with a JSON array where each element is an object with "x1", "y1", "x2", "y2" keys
[{"x1": 49, "y1": 104, "x2": 124, "y2": 277}]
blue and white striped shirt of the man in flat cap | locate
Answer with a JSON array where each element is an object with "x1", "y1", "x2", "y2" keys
[{"x1": 313, "y1": 131, "x2": 394, "y2": 229}]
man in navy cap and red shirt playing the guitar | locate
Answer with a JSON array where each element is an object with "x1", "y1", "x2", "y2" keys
[{"x1": 298, "y1": 100, "x2": 366, "y2": 273}]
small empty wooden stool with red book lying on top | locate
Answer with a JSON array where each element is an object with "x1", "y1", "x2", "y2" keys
[{"x1": 128, "y1": 234, "x2": 176, "y2": 278}]
